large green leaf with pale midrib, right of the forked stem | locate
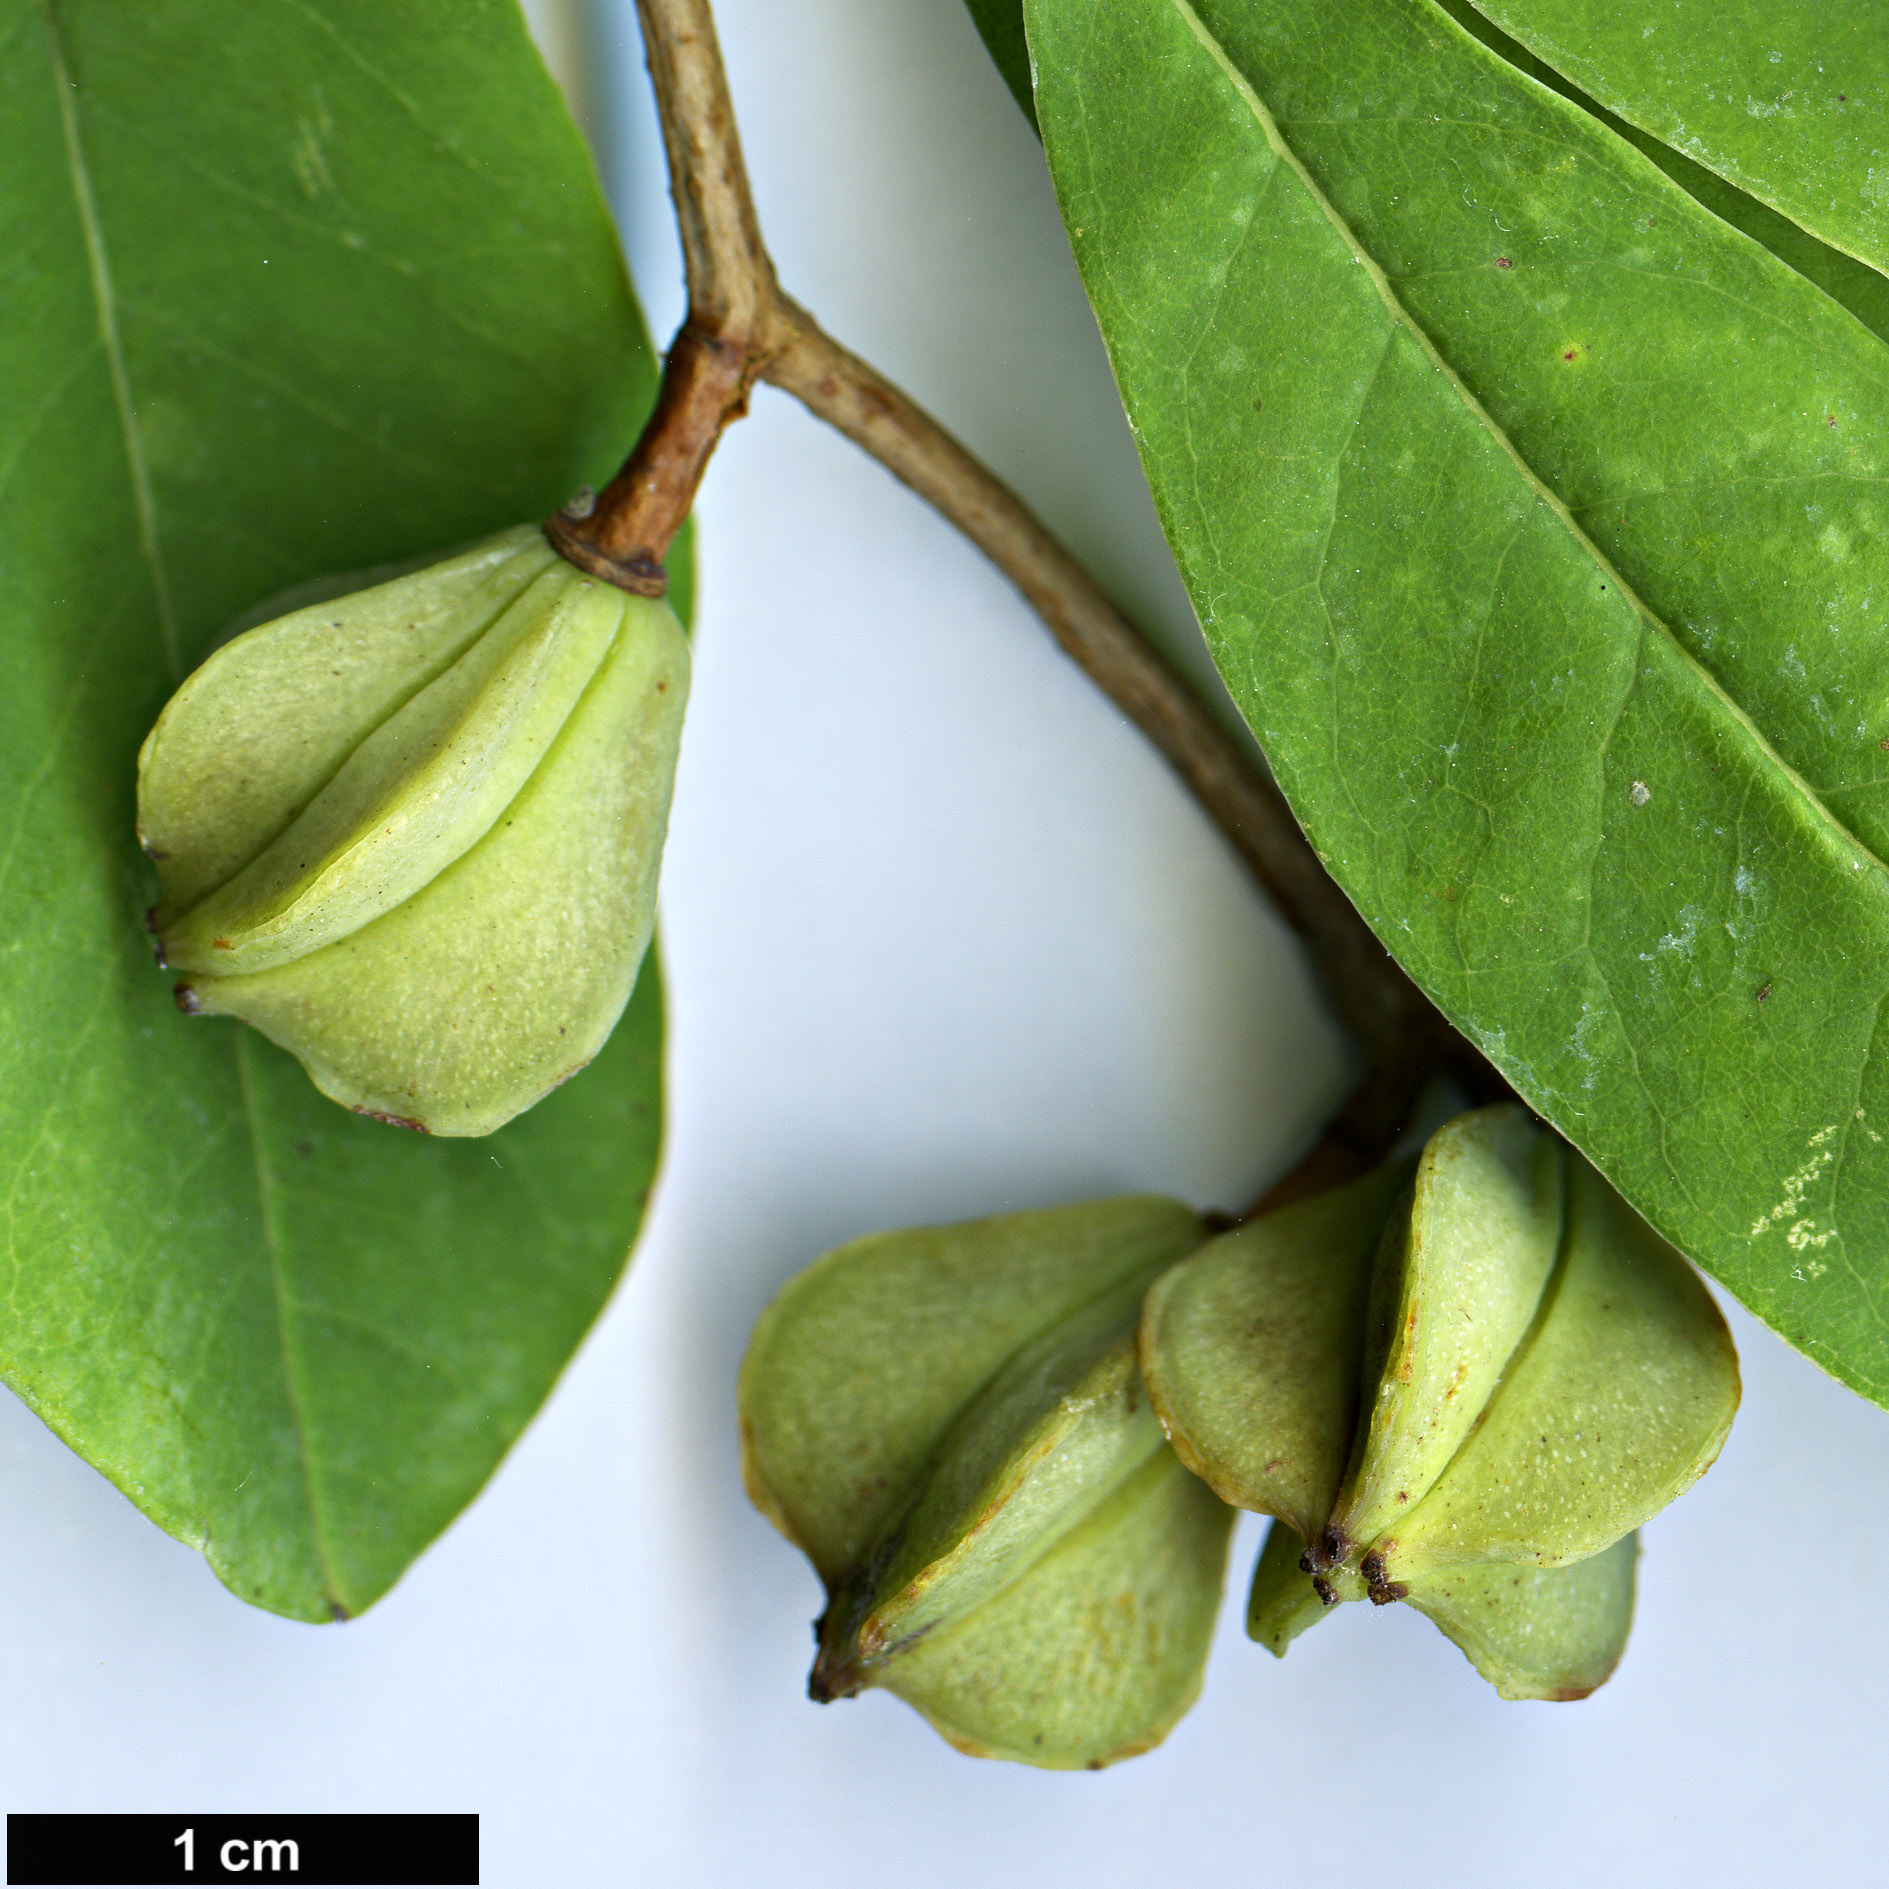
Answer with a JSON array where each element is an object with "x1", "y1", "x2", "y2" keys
[{"x1": 1028, "y1": 0, "x2": 1889, "y2": 1400}]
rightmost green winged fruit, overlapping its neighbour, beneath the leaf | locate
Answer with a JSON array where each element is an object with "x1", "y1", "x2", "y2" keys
[{"x1": 1141, "y1": 1105, "x2": 1738, "y2": 1698}]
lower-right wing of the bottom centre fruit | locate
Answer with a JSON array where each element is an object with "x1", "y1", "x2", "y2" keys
[{"x1": 886, "y1": 1449, "x2": 1234, "y2": 1770}]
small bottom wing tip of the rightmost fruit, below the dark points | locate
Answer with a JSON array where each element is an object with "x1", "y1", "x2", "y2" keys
[{"x1": 1405, "y1": 1534, "x2": 1640, "y2": 1700}]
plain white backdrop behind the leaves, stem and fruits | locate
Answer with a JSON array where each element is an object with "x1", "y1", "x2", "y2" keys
[{"x1": 11, "y1": 0, "x2": 1889, "y2": 1889}]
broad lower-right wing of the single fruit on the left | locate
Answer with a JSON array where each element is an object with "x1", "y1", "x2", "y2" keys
[{"x1": 179, "y1": 597, "x2": 688, "y2": 1135}]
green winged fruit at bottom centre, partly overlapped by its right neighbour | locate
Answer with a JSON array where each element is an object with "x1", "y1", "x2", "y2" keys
[{"x1": 740, "y1": 1196, "x2": 1230, "y2": 1766}]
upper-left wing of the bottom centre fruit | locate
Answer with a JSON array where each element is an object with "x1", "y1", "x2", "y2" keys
[{"x1": 737, "y1": 1194, "x2": 1207, "y2": 1589}]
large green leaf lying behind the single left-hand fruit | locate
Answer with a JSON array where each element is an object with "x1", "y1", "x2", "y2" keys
[{"x1": 0, "y1": 0, "x2": 661, "y2": 1619}]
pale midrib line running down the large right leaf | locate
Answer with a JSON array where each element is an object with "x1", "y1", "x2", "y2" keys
[{"x1": 1167, "y1": 0, "x2": 1889, "y2": 884}]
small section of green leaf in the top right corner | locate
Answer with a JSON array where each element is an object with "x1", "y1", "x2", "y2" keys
[{"x1": 1481, "y1": 0, "x2": 1889, "y2": 268}]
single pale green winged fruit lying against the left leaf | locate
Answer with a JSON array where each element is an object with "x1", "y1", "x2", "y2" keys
[{"x1": 138, "y1": 527, "x2": 689, "y2": 1135}]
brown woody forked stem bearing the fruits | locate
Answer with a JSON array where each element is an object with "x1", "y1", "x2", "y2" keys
[{"x1": 544, "y1": 0, "x2": 1506, "y2": 1178}]
